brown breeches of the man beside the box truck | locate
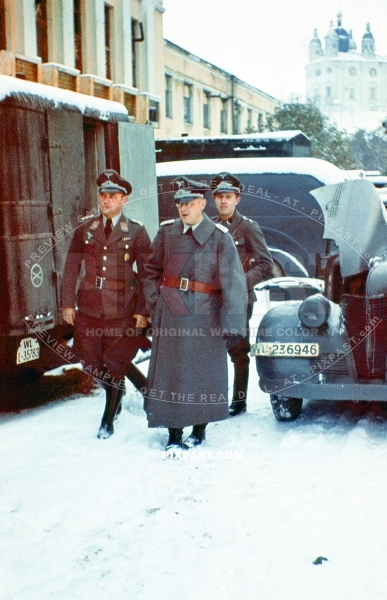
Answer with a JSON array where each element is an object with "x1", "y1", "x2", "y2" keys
[{"x1": 74, "y1": 312, "x2": 138, "y2": 389}]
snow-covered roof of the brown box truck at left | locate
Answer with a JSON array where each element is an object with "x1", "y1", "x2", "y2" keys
[{"x1": 0, "y1": 75, "x2": 128, "y2": 121}]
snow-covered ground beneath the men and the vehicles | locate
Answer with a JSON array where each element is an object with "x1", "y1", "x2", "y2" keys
[{"x1": 0, "y1": 302, "x2": 387, "y2": 600}]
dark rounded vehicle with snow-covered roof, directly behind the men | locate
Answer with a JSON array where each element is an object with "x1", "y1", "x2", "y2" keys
[{"x1": 156, "y1": 157, "x2": 354, "y2": 278}]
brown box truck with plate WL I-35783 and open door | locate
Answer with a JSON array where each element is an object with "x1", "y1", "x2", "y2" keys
[{"x1": 0, "y1": 75, "x2": 158, "y2": 381}]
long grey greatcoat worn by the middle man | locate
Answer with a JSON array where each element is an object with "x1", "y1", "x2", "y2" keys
[{"x1": 144, "y1": 215, "x2": 247, "y2": 428}]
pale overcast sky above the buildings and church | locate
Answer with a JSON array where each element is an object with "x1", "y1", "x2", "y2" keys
[{"x1": 163, "y1": 0, "x2": 387, "y2": 102}]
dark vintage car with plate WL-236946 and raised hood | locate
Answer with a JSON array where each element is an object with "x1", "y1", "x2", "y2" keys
[{"x1": 252, "y1": 179, "x2": 387, "y2": 421}]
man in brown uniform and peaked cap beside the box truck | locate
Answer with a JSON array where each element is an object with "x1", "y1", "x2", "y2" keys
[{"x1": 62, "y1": 170, "x2": 150, "y2": 439}]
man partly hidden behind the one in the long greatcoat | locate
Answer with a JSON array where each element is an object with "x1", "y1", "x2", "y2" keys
[{"x1": 211, "y1": 173, "x2": 273, "y2": 417}]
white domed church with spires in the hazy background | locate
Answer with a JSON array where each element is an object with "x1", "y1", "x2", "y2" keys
[{"x1": 306, "y1": 12, "x2": 387, "y2": 131}]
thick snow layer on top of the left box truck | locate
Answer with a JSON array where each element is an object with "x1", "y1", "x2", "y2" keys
[{"x1": 0, "y1": 75, "x2": 128, "y2": 116}]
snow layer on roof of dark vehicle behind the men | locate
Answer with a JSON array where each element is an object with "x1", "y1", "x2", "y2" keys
[{"x1": 156, "y1": 157, "x2": 349, "y2": 185}]
